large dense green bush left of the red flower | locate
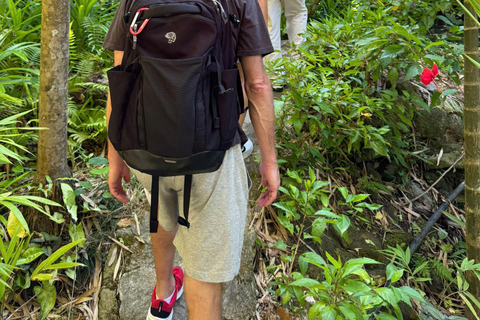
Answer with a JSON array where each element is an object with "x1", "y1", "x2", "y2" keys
[{"x1": 272, "y1": 6, "x2": 461, "y2": 169}]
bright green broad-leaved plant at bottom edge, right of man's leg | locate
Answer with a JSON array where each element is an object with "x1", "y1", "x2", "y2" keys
[{"x1": 273, "y1": 244, "x2": 424, "y2": 320}]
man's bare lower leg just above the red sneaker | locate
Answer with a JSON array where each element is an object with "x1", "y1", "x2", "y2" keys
[{"x1": 150, "y1": 226, "x2": 178, "y2": 299}]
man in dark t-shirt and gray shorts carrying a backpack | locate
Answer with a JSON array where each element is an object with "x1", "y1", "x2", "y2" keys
[{"x1": 104, "y1": 0, "x2": 280, "y2": 320}]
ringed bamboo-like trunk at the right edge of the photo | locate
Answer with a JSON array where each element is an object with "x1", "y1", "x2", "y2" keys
[{"x1": 464, "y1": 1, "x2": 480, "y2": 319}]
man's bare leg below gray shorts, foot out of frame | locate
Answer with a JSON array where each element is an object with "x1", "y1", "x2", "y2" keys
[{"x1": 184, "y1": 275, "x2": 222, "y2": 320}]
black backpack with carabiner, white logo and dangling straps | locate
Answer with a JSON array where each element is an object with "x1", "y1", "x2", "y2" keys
[{"x1": 107, "y1": 0, "x2": 244, "y2": 232}]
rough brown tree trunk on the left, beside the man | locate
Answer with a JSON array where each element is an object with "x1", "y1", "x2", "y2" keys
[{"x1": 34, "y1": 0, "x2": 71, "y2": 183}]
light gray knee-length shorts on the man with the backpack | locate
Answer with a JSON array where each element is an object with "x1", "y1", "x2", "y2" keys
[{"x1": 132, "y1": 145, "x2": 249, "y2": 283}]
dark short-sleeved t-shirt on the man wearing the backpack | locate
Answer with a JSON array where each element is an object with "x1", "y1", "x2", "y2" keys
[{"x1": 103, "y1": 0, "x2": 274, "y2": 58}]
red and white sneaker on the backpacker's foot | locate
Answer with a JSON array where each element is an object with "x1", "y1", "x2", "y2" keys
[{"x1": 147, "y1": 267, "x2": 183, "y2": 320}]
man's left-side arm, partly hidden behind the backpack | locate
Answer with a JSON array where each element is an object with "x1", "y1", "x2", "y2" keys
[{"x1": 107, "y1": 51, "x2": 130, "y2": 203}]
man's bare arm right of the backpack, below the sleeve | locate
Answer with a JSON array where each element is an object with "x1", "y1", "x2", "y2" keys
[{"x1": 240, "y1": 56, "x2": 280, "y2": 207}]
